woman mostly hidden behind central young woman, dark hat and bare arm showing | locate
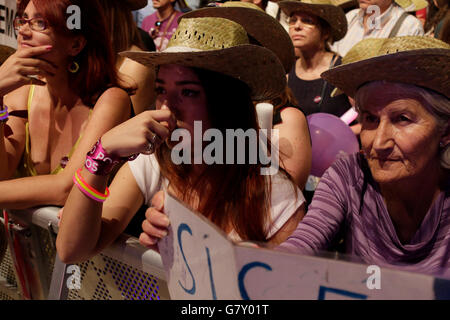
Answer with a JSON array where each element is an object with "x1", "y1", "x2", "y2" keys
[{"x1": 180, "y1": 1, "x2": 311, "y2": 189}]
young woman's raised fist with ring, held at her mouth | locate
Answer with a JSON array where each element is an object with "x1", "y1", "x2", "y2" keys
[{"x1": 102, "y1": 109, "x2": 176, "y2": 157}]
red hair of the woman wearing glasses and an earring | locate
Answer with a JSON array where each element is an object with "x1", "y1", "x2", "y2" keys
[{"x1": 18, "y1": 0, "x2": 132, "y2": 107}]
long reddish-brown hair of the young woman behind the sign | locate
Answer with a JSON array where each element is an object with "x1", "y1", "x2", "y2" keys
[{"x1": 156, "y1": 69, "x2": 280, "y2": 241}]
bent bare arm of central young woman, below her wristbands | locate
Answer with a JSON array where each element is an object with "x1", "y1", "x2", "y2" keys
[{"x1": 56, "y1": 164, "x2": 143, "y2": 263}]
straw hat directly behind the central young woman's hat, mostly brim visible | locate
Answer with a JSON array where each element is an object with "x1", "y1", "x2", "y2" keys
[{"x1": 178, "y1": 1, "x2": 295, "y2": 73}]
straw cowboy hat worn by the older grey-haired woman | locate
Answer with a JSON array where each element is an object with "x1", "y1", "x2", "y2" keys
[{"x1": 321, "y1": 36, "x2": 450, "y2": 98}]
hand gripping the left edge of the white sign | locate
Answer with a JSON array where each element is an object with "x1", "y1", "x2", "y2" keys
[{"x1": 139, "y1": 191, "x2": 170, "y2": 251}]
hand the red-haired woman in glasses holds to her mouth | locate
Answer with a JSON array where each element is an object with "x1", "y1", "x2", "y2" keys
[{"x1": 0, "y1": 46, "x2": 57, "y2": 96}]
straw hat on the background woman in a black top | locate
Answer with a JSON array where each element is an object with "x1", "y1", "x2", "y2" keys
[{"x1": 278, "y1": 0, "x2": 347, "y2": 41}]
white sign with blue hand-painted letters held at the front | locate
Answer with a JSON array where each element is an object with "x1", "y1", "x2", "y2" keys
[{"x1": 159, "y1": 193, "x2": 450, "y2": 300}]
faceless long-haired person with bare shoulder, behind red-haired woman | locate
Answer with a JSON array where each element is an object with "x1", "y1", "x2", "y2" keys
[{"x1": 99, "y1": 0, "x2": 155, "y2": 114}]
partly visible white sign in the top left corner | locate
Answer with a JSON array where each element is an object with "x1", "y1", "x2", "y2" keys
[{"x1": 0, "y1": 0, "x2": 17, "y2": 49}]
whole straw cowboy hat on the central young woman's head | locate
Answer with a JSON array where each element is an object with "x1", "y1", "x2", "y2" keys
[{"x1": 120, "y1": 18, "x2": 286, "y2": 100}]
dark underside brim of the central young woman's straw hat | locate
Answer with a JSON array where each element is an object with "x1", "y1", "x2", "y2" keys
[{"x1": 120, "y1": 44, "x2": 286, "y2": 101}]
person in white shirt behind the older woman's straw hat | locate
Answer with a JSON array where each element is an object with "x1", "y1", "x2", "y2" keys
[{"x1": 331, "y1": 0, "x2": 424, "y2": 57}]
